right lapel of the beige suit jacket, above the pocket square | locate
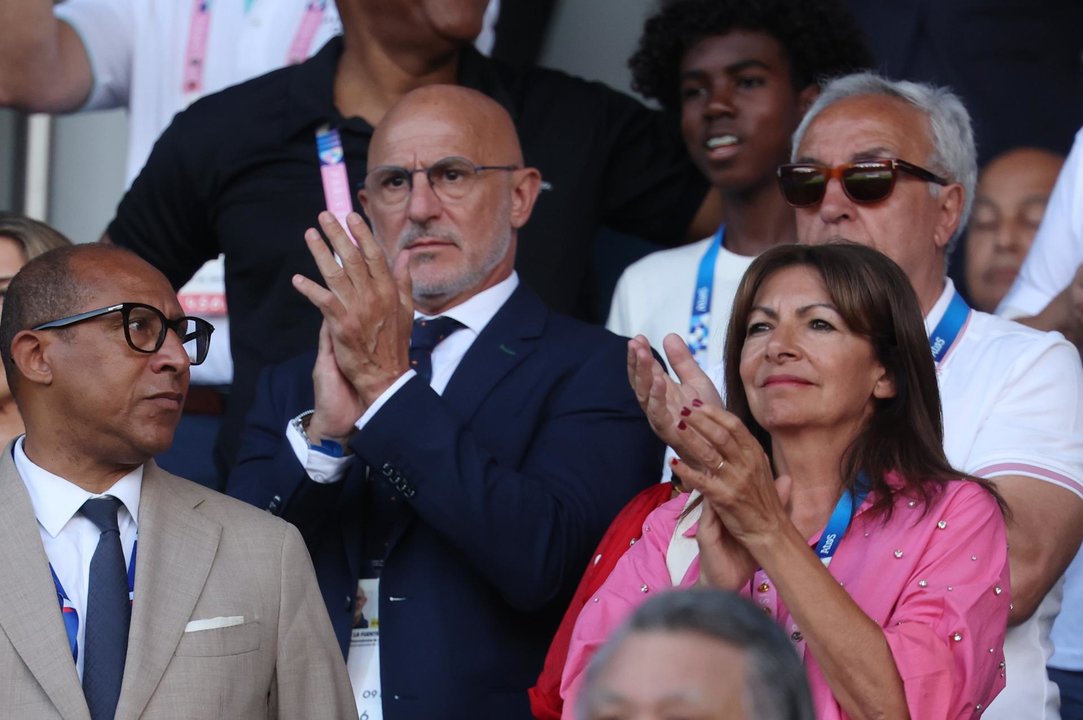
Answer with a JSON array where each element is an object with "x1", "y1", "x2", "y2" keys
[{"x1": 117, "y1": 462, "x2": 222, "y2": 720}]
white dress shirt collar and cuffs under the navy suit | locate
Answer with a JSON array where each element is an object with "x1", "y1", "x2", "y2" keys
[{"x1": 286, "y1": 271, "x2": 519, "y2": 483}]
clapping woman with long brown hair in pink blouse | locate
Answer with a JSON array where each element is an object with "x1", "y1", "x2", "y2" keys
[{"x1": 561, "y1": 245, "x2": 1009, "y2": 720}]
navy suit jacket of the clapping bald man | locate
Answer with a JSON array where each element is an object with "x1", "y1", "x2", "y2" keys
[{"x1": 229, "y1": 286, "x2": 663, "y2": 720}]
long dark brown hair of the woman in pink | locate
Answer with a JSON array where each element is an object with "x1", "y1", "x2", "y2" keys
[{"x1": 725, "y1": 243, "x2": 999, "y2": 516}]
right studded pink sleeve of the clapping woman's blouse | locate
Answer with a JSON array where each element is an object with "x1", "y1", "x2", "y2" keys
[{"x1": 885, "y1": 483, "x2": 1010, "y2": 718}]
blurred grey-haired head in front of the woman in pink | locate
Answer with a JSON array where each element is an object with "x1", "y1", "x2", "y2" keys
[{"x1": 578, "y1": 589, "x2": 813, "y2": 720}]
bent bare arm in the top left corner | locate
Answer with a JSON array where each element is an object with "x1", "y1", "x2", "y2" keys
[{"x1": 0, "y1": 0, "x2": 93, "y2": 113}]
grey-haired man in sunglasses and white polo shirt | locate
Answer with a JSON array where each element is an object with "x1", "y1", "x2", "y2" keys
[{"x1": 779, "y1": 74, "x2": 1083, "y2": 718}]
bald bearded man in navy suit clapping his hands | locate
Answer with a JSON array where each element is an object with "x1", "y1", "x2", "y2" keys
[{"x1": 230, "y1": 86, "x2": 662, "y2": 720}]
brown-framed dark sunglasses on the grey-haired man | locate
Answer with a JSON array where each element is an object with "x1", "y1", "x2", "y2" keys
[{"x1": 779, "y1": 158, "x2": 950, "y2": 208}]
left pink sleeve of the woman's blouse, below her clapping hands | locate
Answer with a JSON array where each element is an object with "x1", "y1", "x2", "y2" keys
[{"x1": 560, "y1": 495, "x2": 694, "y2": 720}]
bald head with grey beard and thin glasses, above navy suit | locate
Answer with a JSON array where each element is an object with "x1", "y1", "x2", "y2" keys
[{"x1": 358, "y1": 86, "x2": 542, "y2": 315}]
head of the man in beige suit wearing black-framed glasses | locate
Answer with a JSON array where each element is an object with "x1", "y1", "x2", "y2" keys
[{"x1": 0, "y1": 245, "x2": 211, "y2": 480}]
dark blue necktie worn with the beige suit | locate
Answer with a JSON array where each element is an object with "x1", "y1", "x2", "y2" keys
[{"x1": 80, "y1": 497, "x2": 132, "y2": 720}]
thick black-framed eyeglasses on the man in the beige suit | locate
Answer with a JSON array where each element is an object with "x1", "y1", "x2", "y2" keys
[{"x1": 31, "y1": 302, "x2": 214, "y2": 365}]
